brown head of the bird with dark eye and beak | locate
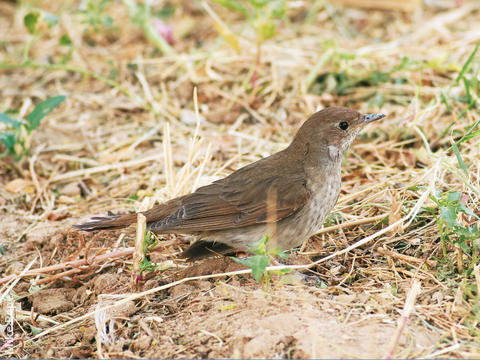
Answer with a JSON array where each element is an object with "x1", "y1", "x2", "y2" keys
[{"x1": 292, "y1": 107, "x2": 385, "y2": 160}]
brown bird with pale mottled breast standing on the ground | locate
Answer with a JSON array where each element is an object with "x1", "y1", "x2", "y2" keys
[{"x1": 74, "y1": 107, "x2": 385, "y2": 261}]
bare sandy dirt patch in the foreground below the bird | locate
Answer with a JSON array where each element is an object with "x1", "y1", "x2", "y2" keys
[{"x1": 25, "y1": 279, "x2": 438, "y2": 358}]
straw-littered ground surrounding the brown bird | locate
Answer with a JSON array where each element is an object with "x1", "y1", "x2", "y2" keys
[{"x1": 0, "y1": 0, "x2": 480, "y2": 358}]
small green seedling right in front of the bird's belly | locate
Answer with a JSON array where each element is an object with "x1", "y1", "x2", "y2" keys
[{"x1": 232, "y1": 235, "x2": 290, "y2": 289}]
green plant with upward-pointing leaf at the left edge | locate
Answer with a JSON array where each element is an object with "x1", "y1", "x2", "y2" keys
[{"x1": 0, "y1": 96, "x2": 65, "y2": 161}]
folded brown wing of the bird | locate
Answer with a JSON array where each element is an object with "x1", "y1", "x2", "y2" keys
[{"x1": 149, "y1": 175, "x2": 310, "y2": 233}]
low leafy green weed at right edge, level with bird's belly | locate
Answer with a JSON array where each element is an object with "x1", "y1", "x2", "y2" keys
[{"x1": 427, "y1": 191, "x2": 480, "y2": 273}]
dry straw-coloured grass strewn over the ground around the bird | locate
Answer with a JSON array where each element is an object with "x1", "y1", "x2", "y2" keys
[{"x1": 0, "y1": 0, "x2": 480, "y2": 358}]
